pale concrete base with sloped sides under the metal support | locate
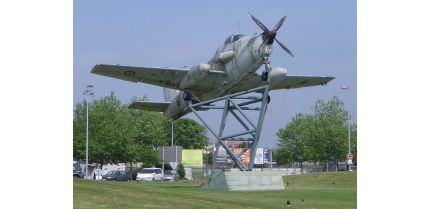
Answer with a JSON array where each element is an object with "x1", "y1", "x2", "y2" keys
[{"x1": 201, "y1": 171, "x2": 285, "y2": 191}]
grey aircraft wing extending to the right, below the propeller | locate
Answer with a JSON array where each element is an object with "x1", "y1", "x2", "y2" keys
[{"x1": 235, "y1": 74, "x2": 334, "y2": 91}]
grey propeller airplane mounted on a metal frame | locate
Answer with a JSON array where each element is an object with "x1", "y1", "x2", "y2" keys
[{"x1": 91, "y1": 14, "x2": 334, "y2": 119}]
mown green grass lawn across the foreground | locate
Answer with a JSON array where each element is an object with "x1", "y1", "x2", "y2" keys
[{"x1": 73, "y1": 172, "x2": 357, "y2": 209}]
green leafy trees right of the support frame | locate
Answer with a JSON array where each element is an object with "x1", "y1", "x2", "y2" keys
[{"x1": 275, "y1": 97, "x2": 357, "y2": 171}]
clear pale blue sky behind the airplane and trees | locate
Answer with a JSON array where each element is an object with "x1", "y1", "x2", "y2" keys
[{"x1": 73, "y1": 0, "x2": 357, "y2": 148}]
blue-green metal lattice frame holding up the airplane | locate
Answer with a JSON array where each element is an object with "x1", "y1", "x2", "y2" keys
[{"x1": 187, "y1": 85, "x2": 269, "y2": 174}]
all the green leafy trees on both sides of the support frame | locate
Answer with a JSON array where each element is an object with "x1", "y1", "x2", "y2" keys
[{"x1": 73, "y1": 92, "x2": 357, "y2": 171}]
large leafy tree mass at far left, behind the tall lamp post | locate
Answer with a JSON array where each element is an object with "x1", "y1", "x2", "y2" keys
[{"x1": 73, "y1": 92, "x2": 167, "y2": 169}]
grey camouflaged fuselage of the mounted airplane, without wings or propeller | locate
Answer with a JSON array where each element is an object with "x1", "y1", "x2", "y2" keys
[{"x1": 164, "y1": 34, "x2": 272, "y2": 118}]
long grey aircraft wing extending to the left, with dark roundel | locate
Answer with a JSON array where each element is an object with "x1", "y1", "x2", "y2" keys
[{"x1": 91, "y1": 64, "x2": 187, "y2": 89}]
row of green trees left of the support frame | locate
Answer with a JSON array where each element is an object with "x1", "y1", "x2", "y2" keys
[{"x1": 73, "y1": 92, "x2": 207, "y2": 169}]
